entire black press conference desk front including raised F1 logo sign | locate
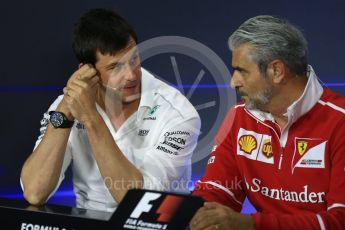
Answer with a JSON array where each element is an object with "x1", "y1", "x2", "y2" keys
[{"x1": 0, "y1": 189, "x2": 203, "y2": 230}]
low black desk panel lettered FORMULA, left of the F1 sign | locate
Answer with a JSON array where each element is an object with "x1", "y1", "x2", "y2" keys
[{"x1": 0, "y1": 198, "x2": 114, "y2": 230}]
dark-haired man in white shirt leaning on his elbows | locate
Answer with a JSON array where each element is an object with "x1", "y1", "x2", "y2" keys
[{"x1": 21, "y1": 9, "x2": 200, "y2": 211}]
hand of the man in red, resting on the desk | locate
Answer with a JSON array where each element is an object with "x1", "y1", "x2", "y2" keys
[{"x1": 190, "y1": 202, "x2": 254, "y2": 230}]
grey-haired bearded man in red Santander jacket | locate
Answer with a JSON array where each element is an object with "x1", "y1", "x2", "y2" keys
[{"x1": 190, "y1": 16, "x2": 345, "y2": 230}]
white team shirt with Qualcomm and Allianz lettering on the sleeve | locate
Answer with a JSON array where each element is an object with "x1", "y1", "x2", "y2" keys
[{"x1": 22, "y1": 68, "x2": 201, "y2": 211}]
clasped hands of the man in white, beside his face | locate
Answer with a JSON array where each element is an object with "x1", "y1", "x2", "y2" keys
[{"x1": 64, "y1": 64, "x2": 99, "y2": 124}]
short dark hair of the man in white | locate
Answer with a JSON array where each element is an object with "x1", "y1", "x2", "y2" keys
[{"x1": 72, "y1": 9, "x2": 137, "y2": 65}]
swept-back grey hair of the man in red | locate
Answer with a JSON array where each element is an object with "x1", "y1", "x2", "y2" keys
[{"x1": 228, "y1": 15, "x2": 308, "y2": 74}]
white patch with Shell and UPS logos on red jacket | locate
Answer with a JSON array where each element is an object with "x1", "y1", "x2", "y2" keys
[{"x1": 237, "y1": 128, "x2": 274, "y2": 164}]
